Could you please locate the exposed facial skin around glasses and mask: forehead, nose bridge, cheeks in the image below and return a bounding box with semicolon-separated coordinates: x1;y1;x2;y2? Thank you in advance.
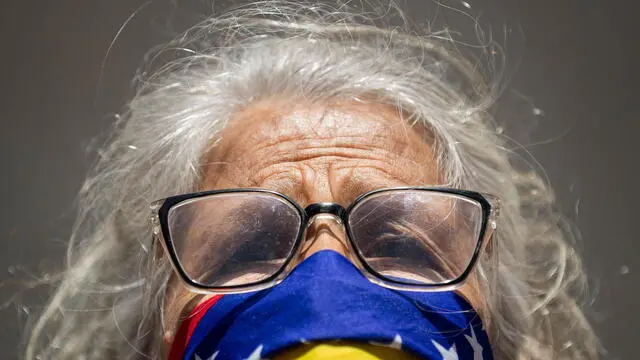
165;101;487;342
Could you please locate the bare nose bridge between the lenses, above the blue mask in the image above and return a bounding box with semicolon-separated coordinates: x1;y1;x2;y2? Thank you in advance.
301;214;349;259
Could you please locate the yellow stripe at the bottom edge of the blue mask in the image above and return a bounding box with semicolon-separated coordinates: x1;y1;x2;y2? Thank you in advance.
274;342;419;360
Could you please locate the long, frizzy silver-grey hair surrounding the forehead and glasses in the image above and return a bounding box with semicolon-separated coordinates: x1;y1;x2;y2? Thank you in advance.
25;1;599;360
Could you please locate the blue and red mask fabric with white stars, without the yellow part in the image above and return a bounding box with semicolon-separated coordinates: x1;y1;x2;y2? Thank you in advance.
169;250;493;360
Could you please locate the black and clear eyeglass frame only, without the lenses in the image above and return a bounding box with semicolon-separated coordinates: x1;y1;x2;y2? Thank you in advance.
151;186;500;294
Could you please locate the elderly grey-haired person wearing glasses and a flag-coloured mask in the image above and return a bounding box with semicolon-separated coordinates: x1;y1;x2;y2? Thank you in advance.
26;2;598;360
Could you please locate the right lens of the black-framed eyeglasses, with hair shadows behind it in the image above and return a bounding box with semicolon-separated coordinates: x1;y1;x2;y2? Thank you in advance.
349;190;482;285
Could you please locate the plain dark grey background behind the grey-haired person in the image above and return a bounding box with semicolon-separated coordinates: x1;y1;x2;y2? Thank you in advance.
0;0;640;359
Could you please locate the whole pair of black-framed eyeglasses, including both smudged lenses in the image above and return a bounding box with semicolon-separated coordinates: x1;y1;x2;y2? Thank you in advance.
151;187;499;294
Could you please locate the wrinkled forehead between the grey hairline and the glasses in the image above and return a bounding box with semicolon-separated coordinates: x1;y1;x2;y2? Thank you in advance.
203;101;439;197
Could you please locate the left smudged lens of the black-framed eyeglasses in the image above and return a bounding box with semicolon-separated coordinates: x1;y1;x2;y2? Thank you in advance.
168;192;302;287
